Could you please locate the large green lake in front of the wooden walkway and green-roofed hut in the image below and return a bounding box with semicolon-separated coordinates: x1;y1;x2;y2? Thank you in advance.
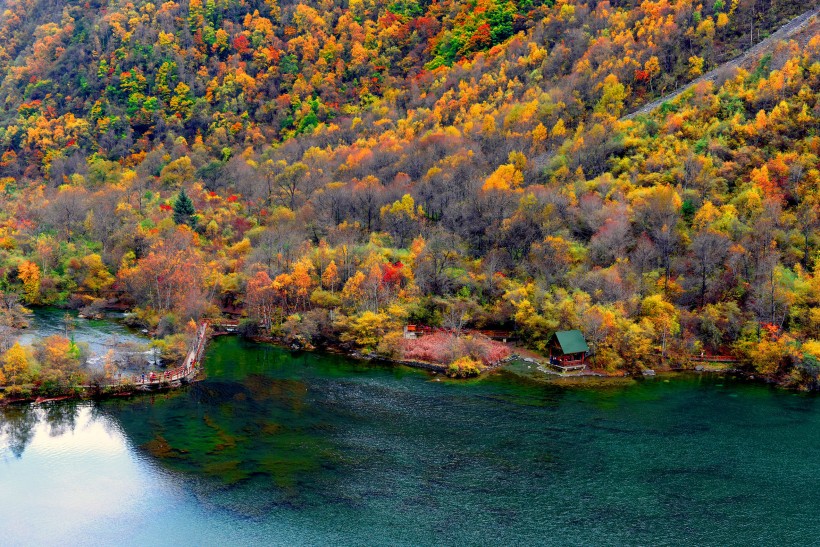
0;338;820;545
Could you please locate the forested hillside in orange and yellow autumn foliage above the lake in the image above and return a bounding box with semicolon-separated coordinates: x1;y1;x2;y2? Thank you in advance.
0;0;820;385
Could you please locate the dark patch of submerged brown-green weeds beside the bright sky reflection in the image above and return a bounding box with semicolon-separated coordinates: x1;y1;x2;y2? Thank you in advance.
100;374;324;508
